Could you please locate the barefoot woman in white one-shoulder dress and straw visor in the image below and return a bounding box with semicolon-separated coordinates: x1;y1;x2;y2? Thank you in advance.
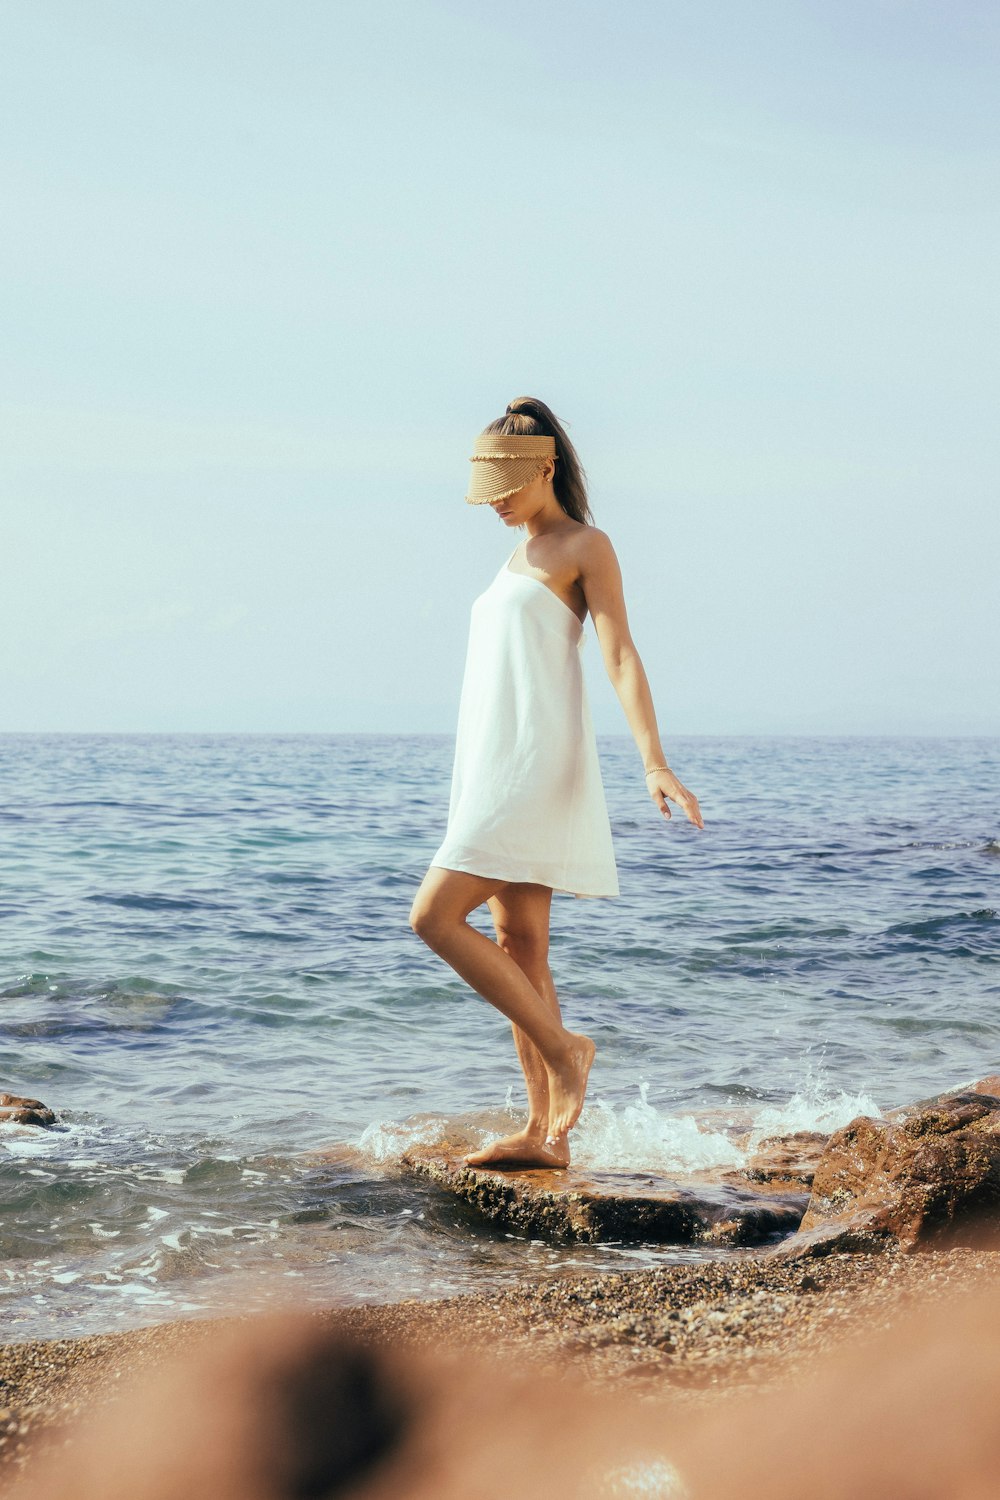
409;396;703;1167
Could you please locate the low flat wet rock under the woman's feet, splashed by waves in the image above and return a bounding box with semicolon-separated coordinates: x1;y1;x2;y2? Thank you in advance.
402;1140;808;1247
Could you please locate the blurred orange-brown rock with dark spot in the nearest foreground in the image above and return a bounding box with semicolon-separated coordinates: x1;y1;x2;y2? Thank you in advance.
15;1260;1000;1500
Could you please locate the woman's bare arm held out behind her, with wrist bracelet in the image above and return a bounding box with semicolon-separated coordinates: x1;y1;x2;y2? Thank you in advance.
580;527;705;828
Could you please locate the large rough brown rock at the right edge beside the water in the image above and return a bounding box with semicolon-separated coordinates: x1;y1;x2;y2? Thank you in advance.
780;1077;1000;1257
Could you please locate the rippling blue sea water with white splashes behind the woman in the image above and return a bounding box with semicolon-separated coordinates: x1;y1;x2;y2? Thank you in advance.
0;735;1000;1338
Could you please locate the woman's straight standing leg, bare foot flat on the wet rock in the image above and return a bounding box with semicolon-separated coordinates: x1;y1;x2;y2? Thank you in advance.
465;882;570;1167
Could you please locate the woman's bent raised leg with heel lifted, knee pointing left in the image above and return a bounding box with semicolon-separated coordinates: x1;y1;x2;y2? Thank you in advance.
409;866;594;1142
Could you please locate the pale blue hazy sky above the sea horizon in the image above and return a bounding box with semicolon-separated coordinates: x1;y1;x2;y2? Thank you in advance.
0;0;1000;738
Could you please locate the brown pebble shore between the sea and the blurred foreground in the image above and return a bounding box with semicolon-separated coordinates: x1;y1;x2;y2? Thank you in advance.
0;1250;1000;1467
